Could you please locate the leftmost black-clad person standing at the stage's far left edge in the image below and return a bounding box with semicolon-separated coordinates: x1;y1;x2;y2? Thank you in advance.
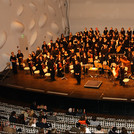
10;52;17;74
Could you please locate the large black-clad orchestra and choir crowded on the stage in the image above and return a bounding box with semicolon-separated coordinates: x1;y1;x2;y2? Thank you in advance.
10;27;134;85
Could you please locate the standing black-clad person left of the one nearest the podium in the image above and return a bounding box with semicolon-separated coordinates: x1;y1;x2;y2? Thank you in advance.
47;55;56;81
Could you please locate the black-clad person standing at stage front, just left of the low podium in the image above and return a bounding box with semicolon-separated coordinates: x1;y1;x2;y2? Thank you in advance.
74;60;81;85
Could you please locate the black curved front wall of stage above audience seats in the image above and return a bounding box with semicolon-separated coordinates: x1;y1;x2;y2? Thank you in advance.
0;87;134;116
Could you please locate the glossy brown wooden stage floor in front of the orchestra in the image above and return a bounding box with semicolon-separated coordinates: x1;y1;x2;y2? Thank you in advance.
1;70;134;101
